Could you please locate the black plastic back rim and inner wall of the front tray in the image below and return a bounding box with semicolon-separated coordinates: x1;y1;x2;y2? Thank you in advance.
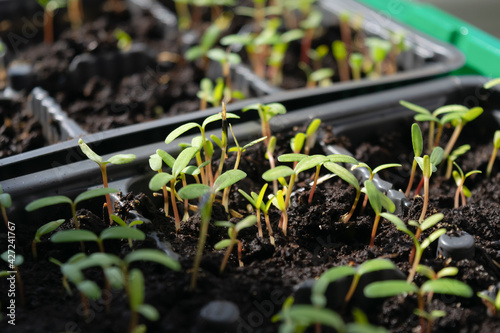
0;76;500;218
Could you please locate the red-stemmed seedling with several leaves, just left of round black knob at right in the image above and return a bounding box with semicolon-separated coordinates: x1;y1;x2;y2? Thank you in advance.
382;213;446;282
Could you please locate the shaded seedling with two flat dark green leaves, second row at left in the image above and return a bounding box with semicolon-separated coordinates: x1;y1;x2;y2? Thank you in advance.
50;226;146;253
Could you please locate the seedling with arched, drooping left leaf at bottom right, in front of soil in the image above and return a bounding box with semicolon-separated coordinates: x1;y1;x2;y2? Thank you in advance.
311;258;396;308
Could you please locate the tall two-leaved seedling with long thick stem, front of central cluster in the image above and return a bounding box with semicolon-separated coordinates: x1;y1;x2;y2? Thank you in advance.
179;170;247;289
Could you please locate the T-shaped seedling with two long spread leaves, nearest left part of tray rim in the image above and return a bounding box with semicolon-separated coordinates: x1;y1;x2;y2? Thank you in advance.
25;188;118;229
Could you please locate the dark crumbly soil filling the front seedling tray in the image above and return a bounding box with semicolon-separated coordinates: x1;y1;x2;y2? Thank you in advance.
0;117;500;332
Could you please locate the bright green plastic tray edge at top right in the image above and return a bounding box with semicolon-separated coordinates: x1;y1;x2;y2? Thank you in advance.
359;0;500;77
